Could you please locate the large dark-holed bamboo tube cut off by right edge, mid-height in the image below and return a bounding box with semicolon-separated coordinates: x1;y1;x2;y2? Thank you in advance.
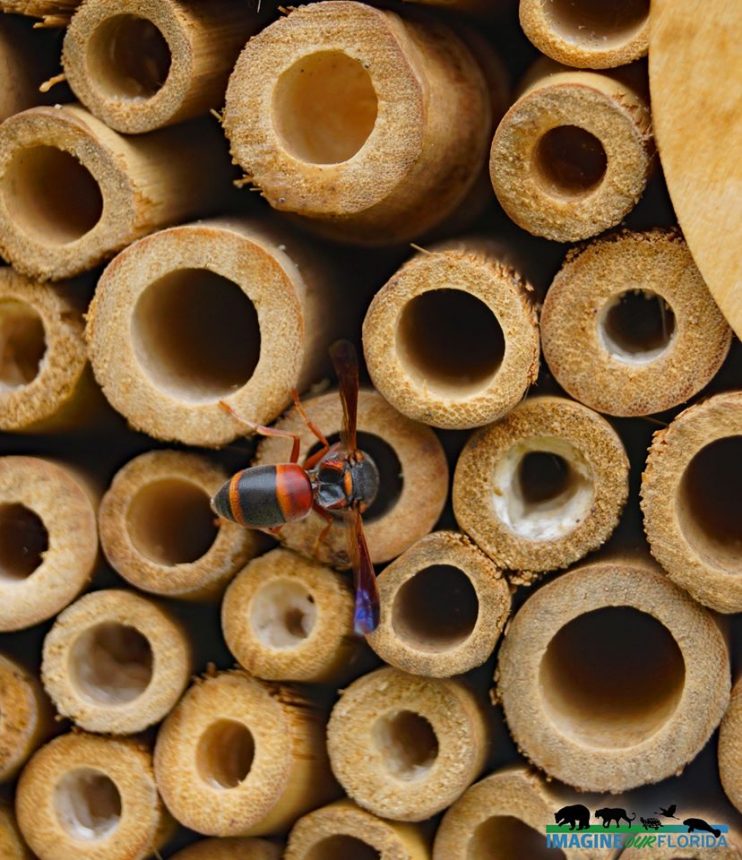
641;391;742;612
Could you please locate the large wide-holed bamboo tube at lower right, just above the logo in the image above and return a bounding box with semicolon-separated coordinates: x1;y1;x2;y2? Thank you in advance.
496;556;730;793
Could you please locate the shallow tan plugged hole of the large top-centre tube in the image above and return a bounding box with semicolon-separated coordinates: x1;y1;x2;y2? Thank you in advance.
273;51;378;164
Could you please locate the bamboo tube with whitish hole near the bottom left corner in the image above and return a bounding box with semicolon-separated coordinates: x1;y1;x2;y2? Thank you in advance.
16;732;172;860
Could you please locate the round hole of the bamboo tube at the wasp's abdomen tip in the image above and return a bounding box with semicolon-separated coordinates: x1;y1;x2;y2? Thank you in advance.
126;478;219;566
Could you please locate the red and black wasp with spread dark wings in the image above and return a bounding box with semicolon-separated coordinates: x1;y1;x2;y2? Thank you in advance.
211;341;379;635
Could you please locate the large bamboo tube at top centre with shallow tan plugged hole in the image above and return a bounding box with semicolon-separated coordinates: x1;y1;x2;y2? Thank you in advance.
224;0;492;244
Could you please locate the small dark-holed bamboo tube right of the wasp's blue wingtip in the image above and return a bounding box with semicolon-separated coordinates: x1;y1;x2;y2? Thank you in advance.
368;531;510;678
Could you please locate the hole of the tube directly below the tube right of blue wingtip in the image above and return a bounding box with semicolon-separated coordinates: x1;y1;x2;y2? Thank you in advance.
372;711;438;780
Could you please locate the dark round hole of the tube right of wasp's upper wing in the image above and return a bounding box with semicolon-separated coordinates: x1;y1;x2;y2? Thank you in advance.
397;289;505;400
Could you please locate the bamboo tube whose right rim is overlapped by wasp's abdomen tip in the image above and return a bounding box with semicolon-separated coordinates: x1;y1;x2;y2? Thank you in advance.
99;451;260;600
